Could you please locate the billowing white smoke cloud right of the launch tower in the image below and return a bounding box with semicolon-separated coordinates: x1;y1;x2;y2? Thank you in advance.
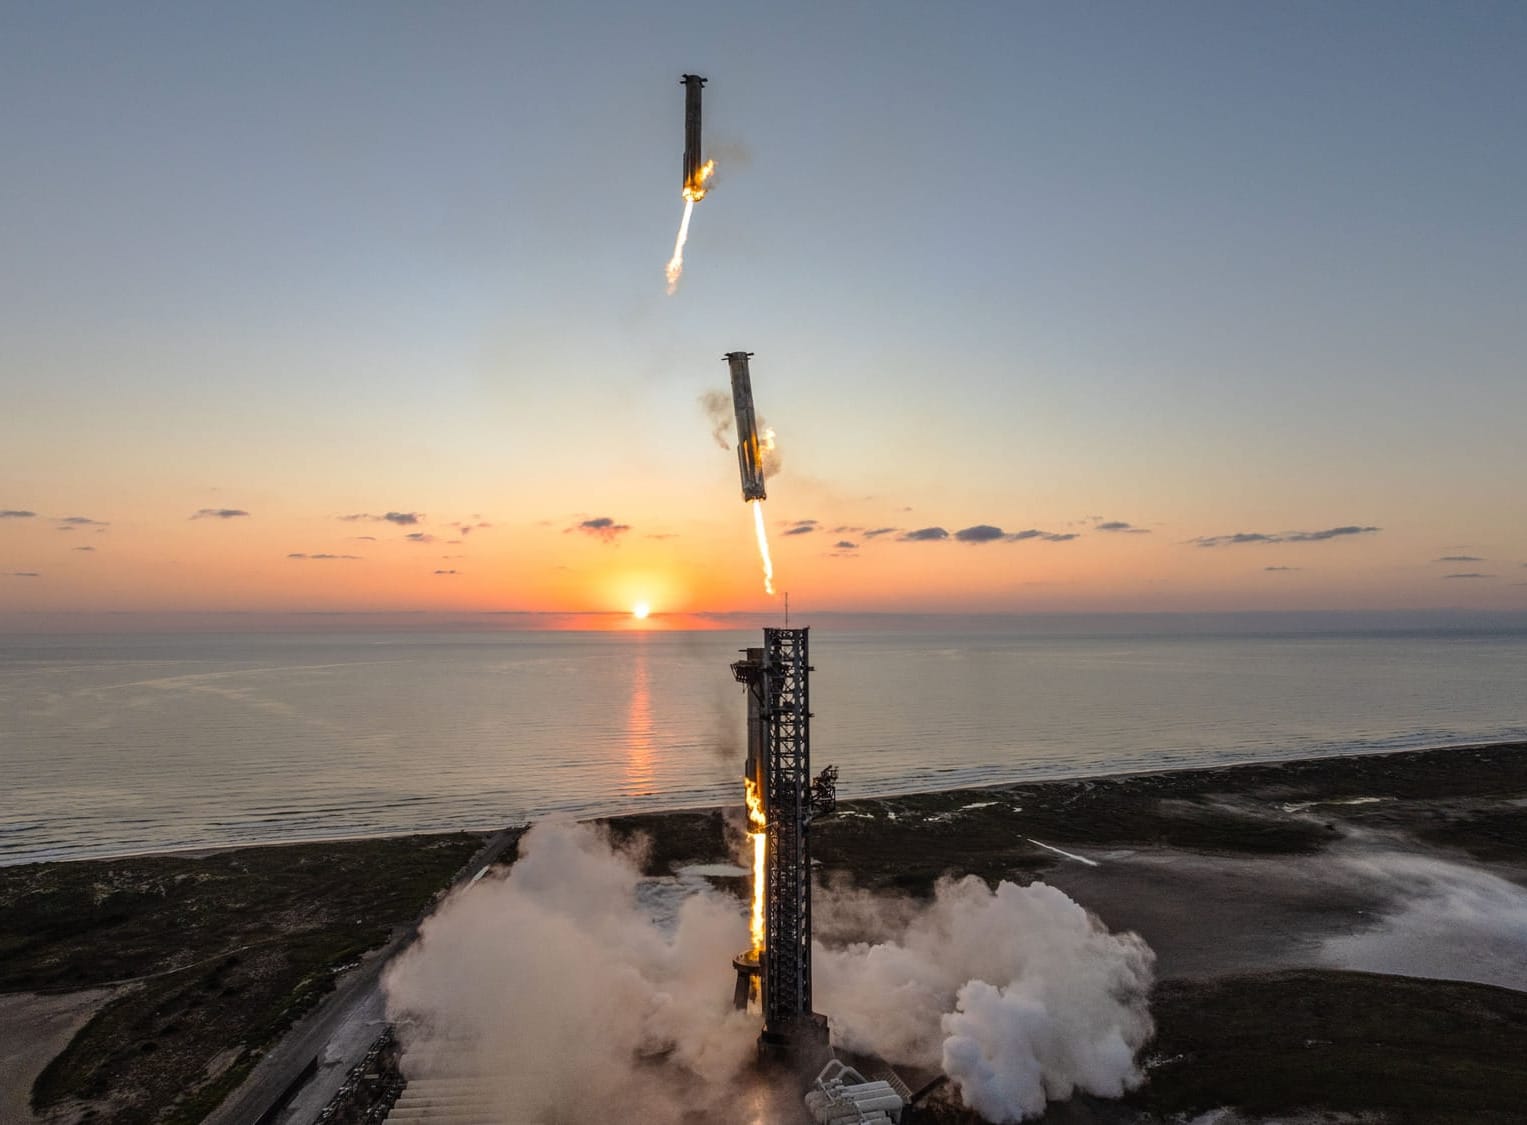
814;876;1156;1122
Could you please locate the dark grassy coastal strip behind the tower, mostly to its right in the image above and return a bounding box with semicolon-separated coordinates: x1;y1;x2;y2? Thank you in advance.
608;743;1527;895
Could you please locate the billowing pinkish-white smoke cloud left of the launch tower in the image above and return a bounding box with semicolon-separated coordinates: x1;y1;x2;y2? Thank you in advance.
385;821;759;1122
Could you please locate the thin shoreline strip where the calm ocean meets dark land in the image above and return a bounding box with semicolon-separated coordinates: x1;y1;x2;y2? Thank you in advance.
11;739;1527;870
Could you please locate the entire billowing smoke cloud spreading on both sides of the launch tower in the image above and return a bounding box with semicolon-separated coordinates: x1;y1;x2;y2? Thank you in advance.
385;820;1154;1122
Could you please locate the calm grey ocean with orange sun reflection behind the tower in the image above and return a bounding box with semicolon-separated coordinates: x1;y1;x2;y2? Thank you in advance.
0;627;1527;864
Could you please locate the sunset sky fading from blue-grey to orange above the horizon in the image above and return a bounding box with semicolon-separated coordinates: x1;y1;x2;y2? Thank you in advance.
0;0;1527;623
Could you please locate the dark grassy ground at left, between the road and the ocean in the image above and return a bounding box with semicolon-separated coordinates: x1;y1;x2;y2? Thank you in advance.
0;833;483;1125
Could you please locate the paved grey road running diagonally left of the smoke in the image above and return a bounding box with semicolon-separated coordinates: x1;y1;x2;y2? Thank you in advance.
203;829;519;1125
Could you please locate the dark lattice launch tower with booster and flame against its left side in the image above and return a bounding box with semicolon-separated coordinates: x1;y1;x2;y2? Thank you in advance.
731;629;837;1062
